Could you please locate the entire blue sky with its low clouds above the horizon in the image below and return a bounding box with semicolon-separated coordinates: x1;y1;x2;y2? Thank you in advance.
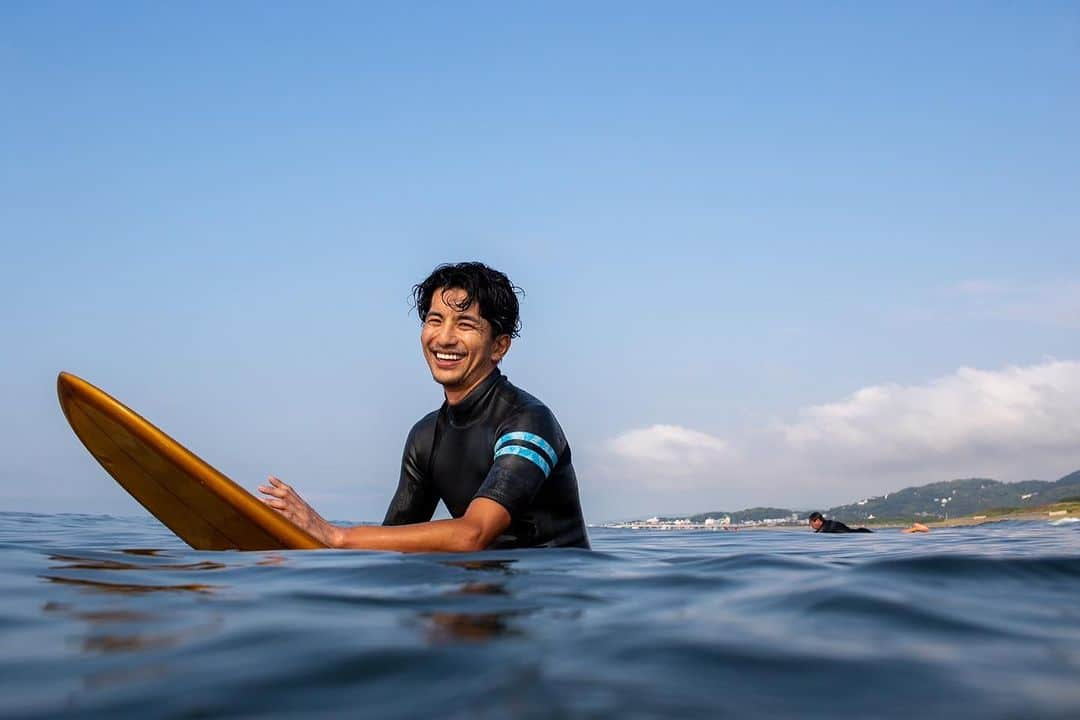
0;2;1080;521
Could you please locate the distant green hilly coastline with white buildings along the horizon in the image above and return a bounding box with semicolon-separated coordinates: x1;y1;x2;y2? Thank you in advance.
660;471;1080;525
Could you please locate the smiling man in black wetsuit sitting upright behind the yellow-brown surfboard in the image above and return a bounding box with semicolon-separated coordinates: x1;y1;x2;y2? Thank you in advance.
259;262;589;552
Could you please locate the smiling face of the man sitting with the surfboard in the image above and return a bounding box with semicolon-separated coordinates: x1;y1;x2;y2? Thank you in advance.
420;287;510;404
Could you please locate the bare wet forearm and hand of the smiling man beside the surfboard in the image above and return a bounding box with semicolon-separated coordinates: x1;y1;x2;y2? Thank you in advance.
259;477;510;553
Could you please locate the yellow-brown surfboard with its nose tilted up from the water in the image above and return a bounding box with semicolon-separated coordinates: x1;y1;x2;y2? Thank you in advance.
56;372;325;551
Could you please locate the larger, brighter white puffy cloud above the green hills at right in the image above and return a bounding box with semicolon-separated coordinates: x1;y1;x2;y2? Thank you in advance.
781;362;1080;472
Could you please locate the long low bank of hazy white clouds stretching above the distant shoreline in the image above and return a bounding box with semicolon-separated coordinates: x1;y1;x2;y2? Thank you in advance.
589;361;1080;516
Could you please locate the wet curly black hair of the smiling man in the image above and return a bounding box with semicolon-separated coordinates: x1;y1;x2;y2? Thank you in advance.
413;262;524;338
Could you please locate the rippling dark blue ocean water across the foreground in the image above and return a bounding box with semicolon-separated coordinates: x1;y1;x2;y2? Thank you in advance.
0;513;1080;719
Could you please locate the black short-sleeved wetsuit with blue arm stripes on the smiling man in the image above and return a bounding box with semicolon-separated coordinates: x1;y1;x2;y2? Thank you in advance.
382;368;589;548
